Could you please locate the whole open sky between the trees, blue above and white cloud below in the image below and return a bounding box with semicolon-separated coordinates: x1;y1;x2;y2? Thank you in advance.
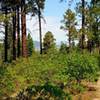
27;0;79;43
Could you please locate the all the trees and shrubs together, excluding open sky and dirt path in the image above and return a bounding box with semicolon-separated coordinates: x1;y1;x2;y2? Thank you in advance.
0;0;100;100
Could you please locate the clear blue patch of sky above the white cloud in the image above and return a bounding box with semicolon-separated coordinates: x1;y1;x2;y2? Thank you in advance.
44;0;76;17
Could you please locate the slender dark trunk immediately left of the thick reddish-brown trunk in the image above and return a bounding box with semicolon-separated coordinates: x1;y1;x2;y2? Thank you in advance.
17;6;21;57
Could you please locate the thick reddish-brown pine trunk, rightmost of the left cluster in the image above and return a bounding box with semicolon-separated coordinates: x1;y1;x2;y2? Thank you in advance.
21;0;27;57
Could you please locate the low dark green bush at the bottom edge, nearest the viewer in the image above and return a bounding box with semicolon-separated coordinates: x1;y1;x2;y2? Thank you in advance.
17;83;71;100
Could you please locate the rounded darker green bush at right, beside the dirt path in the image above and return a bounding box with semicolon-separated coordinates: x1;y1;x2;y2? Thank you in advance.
65;54;100;82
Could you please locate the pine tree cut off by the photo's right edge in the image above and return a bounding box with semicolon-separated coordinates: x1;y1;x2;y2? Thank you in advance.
90;0;100;53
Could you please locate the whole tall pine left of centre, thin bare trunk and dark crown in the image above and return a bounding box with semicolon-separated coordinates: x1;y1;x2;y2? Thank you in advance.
28;0;45;54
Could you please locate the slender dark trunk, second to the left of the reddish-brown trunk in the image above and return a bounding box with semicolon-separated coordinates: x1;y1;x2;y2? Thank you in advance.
13;8;16;60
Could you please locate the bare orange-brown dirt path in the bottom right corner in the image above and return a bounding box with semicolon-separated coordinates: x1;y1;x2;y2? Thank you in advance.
73;78;100;100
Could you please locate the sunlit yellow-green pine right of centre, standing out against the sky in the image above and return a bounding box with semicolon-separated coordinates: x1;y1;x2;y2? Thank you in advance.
61;9;77;48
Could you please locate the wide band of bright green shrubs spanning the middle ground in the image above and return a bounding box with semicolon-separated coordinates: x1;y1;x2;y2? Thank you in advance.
0;52;100;95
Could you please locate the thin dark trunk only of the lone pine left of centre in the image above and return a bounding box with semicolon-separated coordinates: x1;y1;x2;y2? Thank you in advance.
38;7;42;54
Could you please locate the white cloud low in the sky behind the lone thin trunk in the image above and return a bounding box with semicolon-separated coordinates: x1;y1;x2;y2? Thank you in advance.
27;16;67;42
